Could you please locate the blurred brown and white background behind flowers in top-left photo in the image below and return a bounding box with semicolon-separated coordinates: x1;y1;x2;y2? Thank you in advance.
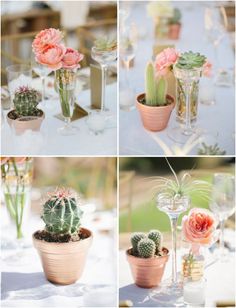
1;1;117;85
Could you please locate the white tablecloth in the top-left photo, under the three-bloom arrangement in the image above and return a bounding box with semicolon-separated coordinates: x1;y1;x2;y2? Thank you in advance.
1;84;117;156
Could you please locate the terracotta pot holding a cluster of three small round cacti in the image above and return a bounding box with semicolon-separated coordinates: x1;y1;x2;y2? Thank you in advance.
126;248;169;288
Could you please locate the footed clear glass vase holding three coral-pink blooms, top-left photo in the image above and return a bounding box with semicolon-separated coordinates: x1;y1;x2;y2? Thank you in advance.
55;69;79;135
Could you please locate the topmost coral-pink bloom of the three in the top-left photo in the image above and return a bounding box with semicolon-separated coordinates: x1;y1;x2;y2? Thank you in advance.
32;28;63;54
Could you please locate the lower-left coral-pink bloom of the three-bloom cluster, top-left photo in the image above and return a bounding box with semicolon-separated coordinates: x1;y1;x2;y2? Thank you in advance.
36;45;66;70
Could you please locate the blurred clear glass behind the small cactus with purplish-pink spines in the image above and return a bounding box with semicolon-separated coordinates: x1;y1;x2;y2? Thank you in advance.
6;64;32;104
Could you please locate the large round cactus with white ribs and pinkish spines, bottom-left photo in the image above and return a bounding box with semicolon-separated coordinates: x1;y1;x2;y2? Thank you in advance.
41;188;83;235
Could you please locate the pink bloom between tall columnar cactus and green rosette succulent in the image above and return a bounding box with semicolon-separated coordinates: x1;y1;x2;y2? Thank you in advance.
155;48;179;76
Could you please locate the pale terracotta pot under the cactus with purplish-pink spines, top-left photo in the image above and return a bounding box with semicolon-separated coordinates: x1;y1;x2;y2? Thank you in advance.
7;110;45;135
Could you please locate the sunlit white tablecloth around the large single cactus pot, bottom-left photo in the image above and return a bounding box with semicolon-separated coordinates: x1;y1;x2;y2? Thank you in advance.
1;208;117;308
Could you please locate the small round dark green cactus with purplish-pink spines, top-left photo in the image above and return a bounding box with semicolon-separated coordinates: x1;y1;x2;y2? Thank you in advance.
13;86;39;117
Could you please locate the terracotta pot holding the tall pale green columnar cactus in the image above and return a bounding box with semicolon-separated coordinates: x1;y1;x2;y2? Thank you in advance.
137;93;175;132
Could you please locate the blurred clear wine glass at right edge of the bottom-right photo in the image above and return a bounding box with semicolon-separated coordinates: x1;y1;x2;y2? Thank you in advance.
210;173;235;261
